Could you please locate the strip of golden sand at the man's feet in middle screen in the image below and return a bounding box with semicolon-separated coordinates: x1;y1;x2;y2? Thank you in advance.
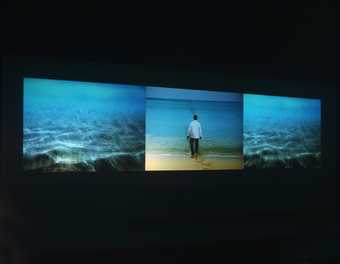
145;154;243;170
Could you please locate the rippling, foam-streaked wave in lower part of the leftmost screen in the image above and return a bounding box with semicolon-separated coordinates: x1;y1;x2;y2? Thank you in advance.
23;106;145;171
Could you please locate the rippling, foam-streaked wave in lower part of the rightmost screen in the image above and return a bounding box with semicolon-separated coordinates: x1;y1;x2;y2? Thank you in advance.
244;122;321;168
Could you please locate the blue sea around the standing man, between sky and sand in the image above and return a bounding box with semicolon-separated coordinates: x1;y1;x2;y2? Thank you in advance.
146;98;243;158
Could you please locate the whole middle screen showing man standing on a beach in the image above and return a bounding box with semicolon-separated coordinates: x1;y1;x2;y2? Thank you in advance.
145;87;243;171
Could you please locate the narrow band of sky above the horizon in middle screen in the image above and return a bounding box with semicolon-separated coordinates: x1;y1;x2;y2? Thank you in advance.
145;86;243;102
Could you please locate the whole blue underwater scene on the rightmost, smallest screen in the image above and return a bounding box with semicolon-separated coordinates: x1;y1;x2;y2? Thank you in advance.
244;94;321;168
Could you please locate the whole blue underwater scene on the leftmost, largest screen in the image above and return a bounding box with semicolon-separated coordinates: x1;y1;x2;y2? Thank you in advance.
23;78;145;171
